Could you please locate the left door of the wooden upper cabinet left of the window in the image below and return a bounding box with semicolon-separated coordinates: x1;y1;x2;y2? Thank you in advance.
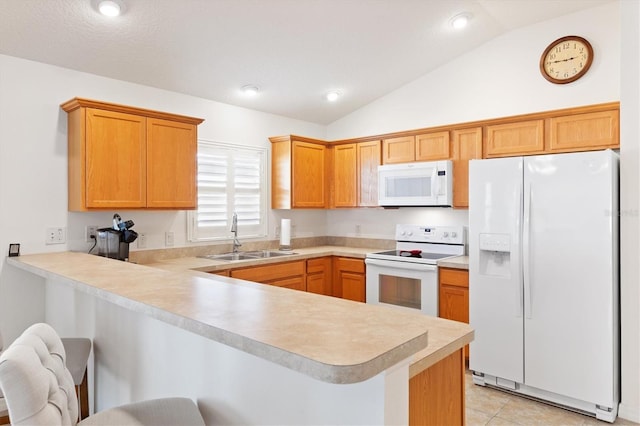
85;108;147;208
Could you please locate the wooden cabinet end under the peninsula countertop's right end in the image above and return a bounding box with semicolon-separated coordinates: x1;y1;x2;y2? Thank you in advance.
409;349;465;426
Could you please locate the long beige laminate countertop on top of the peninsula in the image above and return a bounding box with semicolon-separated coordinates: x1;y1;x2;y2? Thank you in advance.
7;250;473;383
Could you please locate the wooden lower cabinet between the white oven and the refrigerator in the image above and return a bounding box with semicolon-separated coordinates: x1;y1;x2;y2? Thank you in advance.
438;268;469;359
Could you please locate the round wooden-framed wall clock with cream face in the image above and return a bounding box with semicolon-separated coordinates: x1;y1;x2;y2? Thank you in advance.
540;36;593;84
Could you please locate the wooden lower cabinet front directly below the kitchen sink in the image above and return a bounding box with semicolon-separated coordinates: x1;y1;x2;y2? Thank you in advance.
231;260;307;291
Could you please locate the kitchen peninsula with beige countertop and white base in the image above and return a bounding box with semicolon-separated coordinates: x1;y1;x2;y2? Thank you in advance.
7;252;473;424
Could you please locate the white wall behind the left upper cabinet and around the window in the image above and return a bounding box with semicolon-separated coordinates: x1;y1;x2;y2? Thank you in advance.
0;55;326;342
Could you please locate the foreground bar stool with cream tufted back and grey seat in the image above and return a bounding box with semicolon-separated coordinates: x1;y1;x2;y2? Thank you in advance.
0;323;204;426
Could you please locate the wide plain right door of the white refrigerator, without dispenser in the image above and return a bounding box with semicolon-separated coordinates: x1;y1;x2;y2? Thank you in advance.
524;151;618;407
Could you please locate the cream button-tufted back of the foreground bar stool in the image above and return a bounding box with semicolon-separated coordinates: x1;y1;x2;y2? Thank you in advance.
0;323;78;426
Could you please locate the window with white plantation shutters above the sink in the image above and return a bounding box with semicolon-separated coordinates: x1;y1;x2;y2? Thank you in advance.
188;140;267;241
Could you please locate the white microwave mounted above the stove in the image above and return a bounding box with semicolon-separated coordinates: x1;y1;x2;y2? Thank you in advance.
378;160;453;207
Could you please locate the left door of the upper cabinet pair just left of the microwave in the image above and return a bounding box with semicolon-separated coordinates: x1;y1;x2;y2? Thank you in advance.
333;143;358;207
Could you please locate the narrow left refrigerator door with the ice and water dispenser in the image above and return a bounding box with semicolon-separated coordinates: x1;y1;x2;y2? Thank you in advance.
469;157;524;383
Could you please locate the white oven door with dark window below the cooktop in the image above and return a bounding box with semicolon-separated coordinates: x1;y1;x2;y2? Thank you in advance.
365;258;438;317
